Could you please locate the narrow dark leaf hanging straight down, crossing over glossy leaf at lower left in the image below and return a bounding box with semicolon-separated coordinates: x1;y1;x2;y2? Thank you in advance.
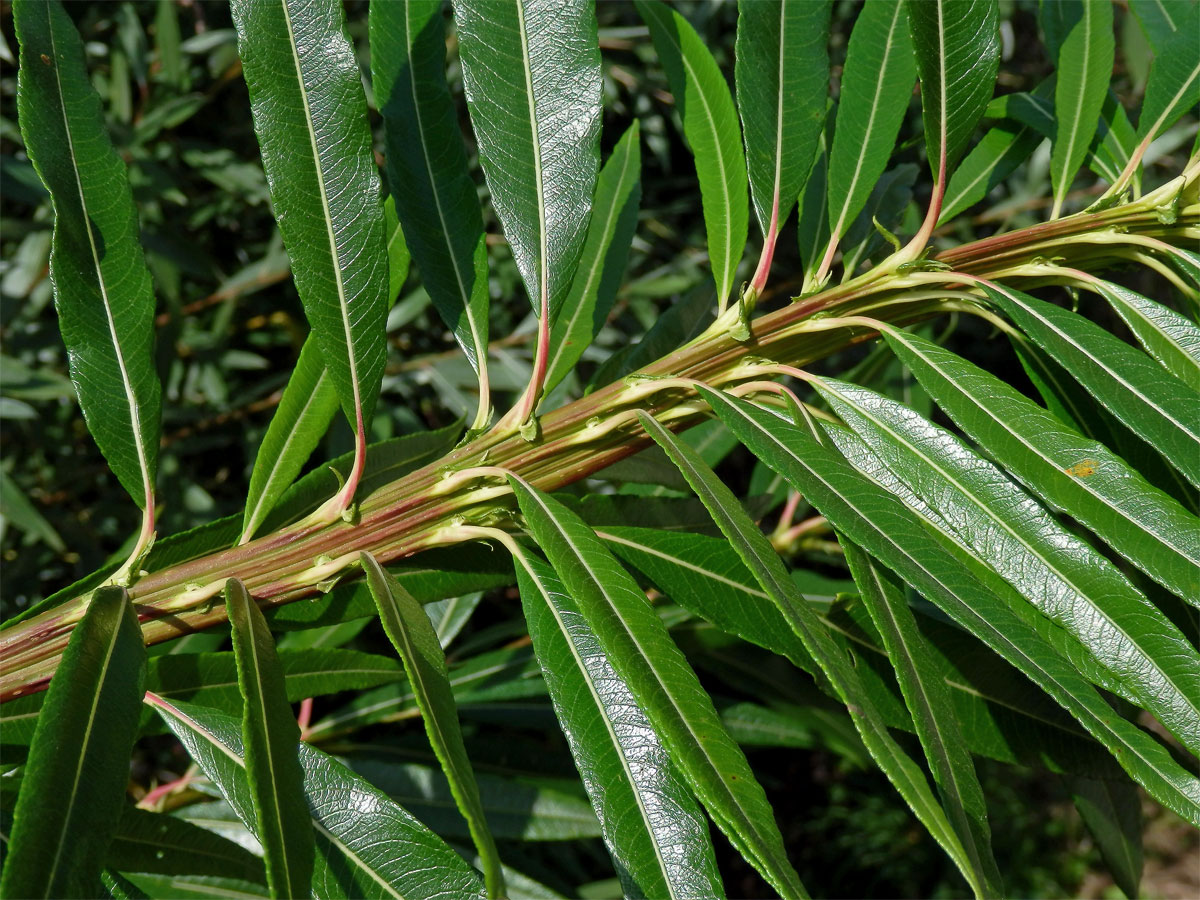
224;578;313;896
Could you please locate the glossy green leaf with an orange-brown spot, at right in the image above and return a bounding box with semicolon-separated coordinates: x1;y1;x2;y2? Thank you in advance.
884;331;1200;607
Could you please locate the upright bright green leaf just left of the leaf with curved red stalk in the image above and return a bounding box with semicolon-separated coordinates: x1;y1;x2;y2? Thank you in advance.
828;1;917;247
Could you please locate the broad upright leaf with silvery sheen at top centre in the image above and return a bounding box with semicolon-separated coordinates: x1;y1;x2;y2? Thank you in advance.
455;0;600;319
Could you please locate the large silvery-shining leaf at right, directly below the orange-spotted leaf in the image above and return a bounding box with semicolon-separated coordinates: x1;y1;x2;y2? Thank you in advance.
817;379;1200;752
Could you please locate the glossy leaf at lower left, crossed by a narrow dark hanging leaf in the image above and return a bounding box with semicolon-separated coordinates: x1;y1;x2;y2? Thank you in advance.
148;695;482;900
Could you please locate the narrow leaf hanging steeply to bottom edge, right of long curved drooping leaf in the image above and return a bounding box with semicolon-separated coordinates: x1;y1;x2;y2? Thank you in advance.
842;541;1003;896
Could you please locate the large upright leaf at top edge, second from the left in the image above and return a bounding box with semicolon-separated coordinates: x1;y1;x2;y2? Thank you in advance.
233;0;388;432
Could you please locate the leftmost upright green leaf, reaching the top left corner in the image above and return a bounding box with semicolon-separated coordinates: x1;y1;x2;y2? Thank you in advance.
13;0;161;520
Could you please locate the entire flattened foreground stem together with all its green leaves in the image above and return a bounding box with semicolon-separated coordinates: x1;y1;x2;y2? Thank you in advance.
0;0;1200;898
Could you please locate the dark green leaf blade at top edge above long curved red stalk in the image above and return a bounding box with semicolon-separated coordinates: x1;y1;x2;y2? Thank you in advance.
905;0;1000;184
